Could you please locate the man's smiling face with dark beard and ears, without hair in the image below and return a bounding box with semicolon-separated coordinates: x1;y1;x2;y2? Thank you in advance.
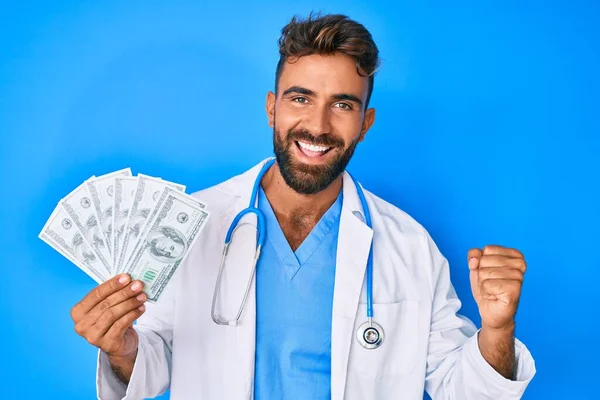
267;54;375;194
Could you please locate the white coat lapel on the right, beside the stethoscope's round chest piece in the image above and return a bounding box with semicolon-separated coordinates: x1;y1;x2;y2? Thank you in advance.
331;173;373;400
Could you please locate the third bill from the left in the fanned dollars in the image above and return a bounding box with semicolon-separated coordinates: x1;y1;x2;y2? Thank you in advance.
87;168;131;256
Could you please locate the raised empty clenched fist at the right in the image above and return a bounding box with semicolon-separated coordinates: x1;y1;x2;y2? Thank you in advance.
468;246;527;329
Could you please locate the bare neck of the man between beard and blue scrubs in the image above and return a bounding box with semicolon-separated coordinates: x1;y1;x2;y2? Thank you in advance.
261;163;342;219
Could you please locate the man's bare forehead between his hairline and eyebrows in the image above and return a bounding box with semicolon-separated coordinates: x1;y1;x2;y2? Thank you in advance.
278;53;369;101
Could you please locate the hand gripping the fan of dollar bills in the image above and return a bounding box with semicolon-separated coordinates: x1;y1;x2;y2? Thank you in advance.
71;274;146;359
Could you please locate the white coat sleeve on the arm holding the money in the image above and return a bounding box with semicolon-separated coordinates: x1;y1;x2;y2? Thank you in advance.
96;282;175;400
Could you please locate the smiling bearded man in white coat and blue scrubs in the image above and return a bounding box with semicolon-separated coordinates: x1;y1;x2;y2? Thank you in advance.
71;15;535;400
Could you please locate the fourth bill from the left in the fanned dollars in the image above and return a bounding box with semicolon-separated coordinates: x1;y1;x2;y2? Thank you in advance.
111;176;138;274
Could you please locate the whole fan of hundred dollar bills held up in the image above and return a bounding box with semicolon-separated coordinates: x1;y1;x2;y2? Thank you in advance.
39;168;209;302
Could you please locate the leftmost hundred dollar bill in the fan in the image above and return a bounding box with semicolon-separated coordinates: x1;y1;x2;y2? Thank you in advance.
39;204;109;283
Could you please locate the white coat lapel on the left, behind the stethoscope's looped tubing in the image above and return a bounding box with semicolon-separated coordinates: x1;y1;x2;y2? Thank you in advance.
216;160;274;399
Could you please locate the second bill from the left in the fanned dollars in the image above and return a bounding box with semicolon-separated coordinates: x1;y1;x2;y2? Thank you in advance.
60;178;111;271
